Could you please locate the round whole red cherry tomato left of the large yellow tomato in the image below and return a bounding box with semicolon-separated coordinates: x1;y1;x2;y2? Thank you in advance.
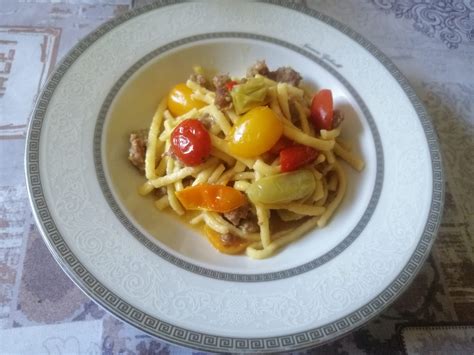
171;118;211;166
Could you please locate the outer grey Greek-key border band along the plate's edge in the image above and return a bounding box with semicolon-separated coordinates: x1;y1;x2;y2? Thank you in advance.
24;0;445;352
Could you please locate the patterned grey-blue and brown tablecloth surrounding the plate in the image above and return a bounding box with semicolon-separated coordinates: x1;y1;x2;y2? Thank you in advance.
0;0;474;354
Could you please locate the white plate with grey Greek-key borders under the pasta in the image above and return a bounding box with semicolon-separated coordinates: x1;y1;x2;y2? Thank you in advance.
26;1;443;351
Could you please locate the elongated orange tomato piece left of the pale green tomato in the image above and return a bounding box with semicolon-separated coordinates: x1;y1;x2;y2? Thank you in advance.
176;184;247;213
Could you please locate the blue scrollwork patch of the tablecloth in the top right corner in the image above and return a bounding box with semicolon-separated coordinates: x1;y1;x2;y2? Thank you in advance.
370;0;474;49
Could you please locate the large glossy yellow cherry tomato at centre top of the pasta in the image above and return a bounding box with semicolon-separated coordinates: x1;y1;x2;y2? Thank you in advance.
229;106;283;158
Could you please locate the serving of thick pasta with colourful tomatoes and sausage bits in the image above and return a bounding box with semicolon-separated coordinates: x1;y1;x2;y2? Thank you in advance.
129;61;364;259
